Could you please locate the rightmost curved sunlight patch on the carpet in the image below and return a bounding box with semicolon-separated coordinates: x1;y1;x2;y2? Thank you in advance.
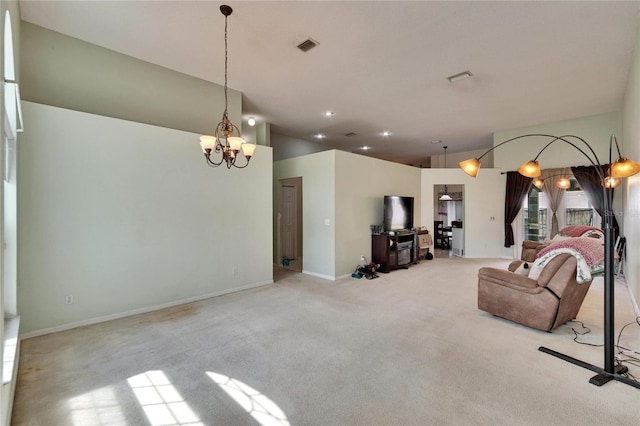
207;371;289;426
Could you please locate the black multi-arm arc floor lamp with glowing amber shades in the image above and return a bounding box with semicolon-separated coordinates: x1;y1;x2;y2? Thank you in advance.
459;133;640;389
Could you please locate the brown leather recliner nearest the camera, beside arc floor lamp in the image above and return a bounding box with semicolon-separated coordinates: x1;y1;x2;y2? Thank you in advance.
478;253;591;331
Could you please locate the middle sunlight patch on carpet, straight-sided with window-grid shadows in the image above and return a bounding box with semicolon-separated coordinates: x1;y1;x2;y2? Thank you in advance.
127;370;204;426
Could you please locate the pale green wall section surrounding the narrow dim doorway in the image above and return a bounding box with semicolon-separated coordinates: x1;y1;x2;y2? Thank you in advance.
273;151;336;279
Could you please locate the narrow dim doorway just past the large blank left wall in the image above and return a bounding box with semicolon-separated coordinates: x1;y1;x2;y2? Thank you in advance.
276;177;303;272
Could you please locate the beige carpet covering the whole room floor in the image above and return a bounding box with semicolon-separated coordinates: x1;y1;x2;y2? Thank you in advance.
13;258;640;426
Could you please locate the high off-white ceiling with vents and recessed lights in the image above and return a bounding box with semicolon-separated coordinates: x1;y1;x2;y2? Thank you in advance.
20;0;640;165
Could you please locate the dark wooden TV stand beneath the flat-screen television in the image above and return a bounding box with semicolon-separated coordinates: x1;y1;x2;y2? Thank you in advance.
371;231;418;272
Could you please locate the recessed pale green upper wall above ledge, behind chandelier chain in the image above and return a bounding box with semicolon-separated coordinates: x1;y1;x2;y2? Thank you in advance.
20;22;242;136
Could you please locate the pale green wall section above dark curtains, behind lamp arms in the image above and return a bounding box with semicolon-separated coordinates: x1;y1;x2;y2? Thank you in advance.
493;111;622;171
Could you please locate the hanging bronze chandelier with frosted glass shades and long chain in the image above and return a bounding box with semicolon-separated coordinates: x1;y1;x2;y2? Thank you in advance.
200;4;256;169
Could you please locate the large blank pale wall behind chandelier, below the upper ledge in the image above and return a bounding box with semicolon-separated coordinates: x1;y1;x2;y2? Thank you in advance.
18;102;273;335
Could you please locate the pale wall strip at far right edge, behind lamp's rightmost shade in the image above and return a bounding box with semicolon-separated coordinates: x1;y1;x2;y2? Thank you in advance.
617;18;640;315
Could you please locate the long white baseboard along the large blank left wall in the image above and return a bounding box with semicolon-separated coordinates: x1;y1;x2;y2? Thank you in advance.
20;280;273;340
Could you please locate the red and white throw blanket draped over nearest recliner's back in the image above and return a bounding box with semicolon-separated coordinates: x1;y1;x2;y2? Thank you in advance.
534;237;604;284
